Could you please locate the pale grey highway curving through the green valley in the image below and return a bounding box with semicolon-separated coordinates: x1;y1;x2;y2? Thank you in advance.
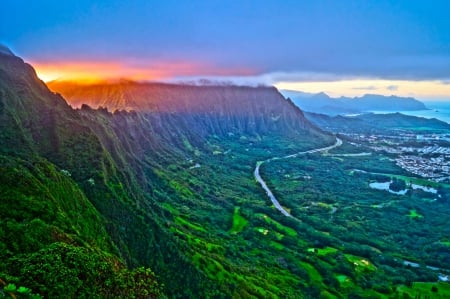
253;137;342;217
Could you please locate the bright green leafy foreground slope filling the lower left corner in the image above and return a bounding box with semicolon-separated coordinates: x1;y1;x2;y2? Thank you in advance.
0;156;161;298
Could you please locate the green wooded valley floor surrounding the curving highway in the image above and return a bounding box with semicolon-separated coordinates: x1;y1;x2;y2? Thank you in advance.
156;133;450;298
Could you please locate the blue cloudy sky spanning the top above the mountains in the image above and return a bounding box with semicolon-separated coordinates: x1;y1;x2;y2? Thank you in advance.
0;0;450;99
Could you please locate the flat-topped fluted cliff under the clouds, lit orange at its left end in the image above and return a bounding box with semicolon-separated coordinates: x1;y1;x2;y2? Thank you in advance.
49;82;317;135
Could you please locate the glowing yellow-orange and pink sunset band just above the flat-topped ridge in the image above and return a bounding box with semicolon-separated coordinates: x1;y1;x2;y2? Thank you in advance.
31;61;255;82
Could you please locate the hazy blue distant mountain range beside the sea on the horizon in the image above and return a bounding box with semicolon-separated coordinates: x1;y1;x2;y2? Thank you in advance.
281;90;427;115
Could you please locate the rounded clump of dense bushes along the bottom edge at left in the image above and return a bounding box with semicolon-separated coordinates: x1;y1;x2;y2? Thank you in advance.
3;243;161;298
